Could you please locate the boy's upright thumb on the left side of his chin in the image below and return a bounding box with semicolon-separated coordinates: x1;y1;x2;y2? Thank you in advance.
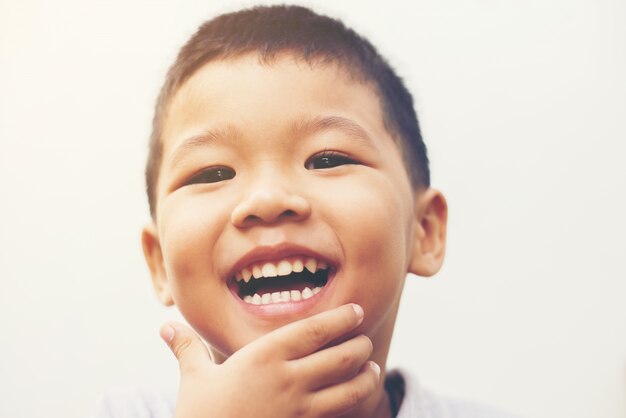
160;322;212;374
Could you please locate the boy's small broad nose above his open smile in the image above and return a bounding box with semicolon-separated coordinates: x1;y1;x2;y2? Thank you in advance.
231;184;311;228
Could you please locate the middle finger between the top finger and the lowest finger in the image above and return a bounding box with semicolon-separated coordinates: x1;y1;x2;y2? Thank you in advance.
291;335;372;390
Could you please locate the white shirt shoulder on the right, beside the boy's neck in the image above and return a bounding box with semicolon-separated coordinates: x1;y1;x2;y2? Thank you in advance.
391;370;518;418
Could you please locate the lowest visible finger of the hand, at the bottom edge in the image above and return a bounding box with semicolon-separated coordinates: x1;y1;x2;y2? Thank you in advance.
310;361;380;416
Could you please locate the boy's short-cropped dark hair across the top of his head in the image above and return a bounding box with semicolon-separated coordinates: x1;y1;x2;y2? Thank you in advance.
146;6;430;217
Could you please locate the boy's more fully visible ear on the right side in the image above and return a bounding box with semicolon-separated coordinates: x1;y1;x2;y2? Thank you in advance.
409;188;448;277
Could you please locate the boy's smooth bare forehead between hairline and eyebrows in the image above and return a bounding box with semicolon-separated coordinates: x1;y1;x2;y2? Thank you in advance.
161;54;386;155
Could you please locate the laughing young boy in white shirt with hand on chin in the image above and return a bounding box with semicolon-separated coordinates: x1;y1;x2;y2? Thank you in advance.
97;6;516;418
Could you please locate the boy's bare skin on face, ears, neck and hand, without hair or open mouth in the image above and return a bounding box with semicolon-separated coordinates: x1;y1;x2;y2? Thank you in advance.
142;54;447;417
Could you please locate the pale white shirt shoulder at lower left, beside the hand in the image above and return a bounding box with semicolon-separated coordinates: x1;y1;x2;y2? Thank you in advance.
92;387;176;418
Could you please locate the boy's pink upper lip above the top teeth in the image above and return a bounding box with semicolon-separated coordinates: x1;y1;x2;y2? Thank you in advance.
226;243;337;282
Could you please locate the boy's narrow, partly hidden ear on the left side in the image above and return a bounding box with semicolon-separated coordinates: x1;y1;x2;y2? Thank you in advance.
141;222;174;306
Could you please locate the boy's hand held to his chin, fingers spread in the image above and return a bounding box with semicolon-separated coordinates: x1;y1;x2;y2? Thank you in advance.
161;304;380;418
